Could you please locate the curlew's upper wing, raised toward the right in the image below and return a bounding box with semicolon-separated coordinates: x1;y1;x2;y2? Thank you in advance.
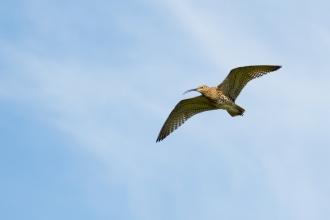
218;66;281;101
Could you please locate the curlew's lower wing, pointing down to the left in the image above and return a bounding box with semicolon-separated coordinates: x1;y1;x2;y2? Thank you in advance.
156;96;218;142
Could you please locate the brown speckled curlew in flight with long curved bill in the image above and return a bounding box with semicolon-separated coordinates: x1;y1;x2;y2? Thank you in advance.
156;65;281;143
